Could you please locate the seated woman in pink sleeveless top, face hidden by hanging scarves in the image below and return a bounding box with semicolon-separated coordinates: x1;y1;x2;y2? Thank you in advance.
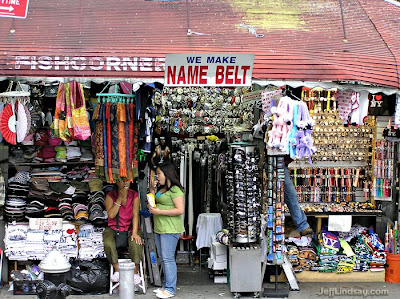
103;182;143;284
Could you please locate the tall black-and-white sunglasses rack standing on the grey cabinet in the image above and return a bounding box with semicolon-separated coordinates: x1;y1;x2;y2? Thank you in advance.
226;145;261;244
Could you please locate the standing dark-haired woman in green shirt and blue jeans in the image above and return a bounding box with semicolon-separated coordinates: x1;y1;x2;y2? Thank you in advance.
149;162;185;298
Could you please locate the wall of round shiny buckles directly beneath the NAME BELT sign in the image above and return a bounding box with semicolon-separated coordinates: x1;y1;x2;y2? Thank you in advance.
155;87;254;136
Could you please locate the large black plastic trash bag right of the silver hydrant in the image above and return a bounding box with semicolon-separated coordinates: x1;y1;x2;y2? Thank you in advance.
66;260;110;294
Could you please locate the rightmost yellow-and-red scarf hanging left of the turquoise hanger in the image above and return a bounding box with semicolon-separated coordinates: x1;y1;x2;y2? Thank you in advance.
71;82;91;140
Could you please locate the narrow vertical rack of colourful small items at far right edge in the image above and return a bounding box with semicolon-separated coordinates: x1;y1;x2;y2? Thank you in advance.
373;140;394;201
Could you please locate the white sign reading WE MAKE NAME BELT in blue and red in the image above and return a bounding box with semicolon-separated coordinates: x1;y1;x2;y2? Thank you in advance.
164;53;254;86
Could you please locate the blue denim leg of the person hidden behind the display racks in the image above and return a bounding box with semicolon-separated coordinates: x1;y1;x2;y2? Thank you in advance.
285;166;310;232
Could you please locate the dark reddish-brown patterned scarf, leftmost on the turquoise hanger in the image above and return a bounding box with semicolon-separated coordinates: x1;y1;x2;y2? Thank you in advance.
92;103;105;180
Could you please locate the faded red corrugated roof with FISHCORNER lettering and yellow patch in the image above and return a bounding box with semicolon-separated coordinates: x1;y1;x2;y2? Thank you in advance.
0;0;400;88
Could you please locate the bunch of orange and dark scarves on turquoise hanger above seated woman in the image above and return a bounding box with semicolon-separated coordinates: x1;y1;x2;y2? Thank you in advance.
92;84;139;183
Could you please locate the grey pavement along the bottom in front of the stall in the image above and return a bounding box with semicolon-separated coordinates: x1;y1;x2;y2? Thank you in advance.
0;266;400;299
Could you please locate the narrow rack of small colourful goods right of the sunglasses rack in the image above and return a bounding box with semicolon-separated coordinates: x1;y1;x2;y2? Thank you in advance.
264;156;285;264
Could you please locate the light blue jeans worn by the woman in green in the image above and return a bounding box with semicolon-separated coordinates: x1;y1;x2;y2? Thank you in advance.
155;233;180;295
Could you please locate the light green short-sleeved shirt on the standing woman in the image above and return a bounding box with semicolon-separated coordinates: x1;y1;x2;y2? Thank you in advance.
153;186;185;234
